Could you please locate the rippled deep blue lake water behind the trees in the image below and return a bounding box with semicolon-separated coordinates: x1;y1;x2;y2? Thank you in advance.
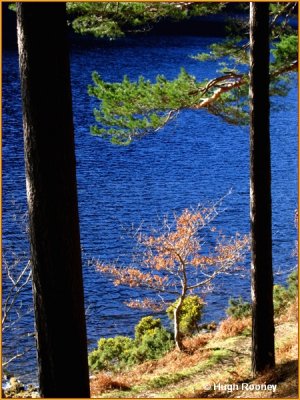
2;36;297;382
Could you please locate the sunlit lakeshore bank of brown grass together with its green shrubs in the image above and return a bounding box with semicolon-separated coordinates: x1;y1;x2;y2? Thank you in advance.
2;275;298;398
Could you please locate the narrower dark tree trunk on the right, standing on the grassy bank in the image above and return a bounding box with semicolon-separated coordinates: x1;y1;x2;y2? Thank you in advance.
250;2;275;375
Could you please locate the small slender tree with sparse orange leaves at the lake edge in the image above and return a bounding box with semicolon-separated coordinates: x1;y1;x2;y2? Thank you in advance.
97;206;249;350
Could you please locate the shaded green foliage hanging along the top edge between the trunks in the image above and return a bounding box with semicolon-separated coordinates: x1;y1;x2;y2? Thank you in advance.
67;2;225;40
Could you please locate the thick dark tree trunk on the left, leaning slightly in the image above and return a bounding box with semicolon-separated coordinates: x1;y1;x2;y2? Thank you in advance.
17;3;89;398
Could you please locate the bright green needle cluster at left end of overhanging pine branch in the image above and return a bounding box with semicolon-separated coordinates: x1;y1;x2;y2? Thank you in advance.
88;68;201;145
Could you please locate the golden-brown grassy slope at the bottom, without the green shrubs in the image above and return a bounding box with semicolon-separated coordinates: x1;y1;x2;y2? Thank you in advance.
91;300;298;398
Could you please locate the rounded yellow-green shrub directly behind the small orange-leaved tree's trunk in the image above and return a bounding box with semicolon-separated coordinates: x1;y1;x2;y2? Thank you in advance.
167;295;204;335
